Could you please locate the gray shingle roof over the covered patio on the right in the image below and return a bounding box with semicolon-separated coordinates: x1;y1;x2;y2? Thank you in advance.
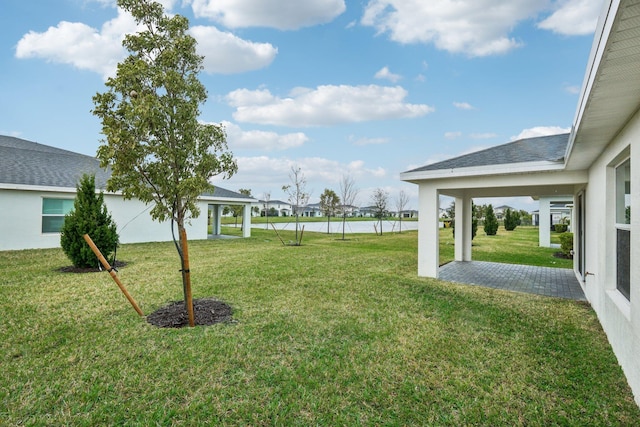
409;133;569;172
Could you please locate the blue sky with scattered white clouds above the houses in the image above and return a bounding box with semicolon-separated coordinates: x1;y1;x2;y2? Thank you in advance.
0;0;603;210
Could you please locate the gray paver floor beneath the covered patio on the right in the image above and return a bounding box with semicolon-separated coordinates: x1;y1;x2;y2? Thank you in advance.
438;261;587;301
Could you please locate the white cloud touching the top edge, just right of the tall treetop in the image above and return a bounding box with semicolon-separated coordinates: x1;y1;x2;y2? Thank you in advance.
191;0;346;30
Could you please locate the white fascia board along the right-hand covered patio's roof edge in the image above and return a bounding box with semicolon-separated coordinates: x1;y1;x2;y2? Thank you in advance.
400;161;564;182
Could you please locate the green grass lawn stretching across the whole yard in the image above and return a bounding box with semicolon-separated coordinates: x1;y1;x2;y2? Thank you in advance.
0;229;640;426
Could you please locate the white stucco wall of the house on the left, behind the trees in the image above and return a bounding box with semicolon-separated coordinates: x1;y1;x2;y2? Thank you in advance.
0;189;208;250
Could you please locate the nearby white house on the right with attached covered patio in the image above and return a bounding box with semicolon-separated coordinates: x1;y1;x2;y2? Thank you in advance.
401;0;640;404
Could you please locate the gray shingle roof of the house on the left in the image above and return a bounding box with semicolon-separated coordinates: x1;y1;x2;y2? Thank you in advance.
0;135;252;200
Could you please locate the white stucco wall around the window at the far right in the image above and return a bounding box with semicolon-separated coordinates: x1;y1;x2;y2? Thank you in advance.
576;108;640;404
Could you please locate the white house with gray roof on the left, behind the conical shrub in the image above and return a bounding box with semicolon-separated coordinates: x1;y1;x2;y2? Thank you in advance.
0;136;255;250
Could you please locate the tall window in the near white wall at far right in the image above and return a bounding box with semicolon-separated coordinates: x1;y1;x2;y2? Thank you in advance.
615;159;631;300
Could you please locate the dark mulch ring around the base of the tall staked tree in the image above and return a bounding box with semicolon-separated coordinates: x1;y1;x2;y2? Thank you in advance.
147;298;233;328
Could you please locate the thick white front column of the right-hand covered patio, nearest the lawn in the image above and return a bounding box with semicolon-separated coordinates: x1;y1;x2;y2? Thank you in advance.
418;183;440;278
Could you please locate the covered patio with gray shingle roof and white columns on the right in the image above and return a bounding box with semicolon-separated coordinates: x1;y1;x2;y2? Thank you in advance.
401;134;588;278
